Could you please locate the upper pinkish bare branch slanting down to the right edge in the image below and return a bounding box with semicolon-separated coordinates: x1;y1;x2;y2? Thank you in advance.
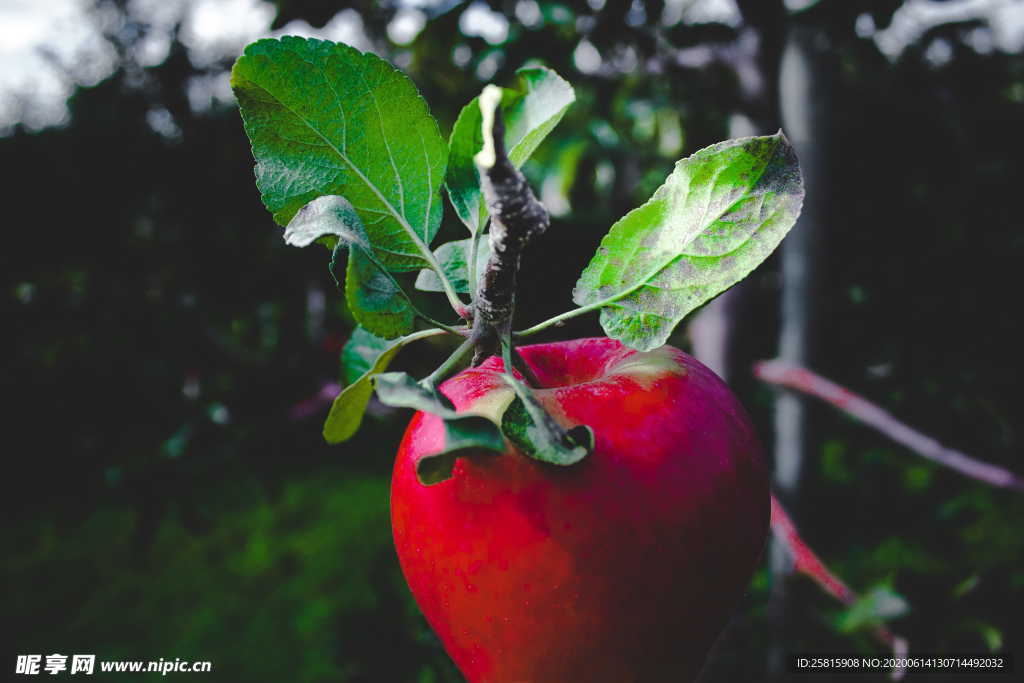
754;360;1024;492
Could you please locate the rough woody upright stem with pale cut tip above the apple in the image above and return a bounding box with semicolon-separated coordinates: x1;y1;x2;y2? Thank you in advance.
470;102;551;366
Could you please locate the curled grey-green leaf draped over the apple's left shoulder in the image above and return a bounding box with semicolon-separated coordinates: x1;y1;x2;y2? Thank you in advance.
374;373;505;485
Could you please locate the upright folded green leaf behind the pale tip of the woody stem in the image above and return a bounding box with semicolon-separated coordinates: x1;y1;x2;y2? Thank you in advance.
445;67;575;234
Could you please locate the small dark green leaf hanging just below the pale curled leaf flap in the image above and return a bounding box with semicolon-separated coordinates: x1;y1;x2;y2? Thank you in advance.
345;244;416;339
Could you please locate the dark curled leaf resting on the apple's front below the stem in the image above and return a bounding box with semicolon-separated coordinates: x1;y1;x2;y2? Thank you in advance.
502;375;594;465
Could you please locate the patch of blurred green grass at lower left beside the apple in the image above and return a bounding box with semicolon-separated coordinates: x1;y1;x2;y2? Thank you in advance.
7;475;456;681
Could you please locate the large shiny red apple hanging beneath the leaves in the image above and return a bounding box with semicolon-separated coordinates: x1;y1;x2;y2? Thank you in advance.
391;338;769;683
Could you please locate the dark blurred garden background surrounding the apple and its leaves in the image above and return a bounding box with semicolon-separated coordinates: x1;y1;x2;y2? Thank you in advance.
0;0;1024;683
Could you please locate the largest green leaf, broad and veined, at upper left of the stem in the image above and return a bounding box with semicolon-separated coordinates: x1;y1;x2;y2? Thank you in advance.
231;36;447;270
